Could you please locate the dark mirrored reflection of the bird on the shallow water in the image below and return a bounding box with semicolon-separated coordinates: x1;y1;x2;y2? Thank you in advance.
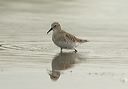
49;52;79;81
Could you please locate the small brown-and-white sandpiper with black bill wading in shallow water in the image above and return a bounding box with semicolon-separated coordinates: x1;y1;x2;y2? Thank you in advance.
47;22;88;52
